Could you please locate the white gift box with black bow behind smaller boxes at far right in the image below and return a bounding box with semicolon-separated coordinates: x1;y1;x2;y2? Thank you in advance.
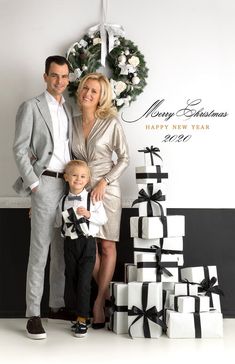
180;265;223;312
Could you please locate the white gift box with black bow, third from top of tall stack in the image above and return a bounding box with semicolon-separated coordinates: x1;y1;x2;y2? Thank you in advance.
132;183;166;216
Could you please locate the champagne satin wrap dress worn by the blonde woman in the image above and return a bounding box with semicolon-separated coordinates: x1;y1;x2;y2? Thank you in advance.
72;116;129;241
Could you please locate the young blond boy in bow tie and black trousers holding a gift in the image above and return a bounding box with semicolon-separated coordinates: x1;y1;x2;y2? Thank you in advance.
56;160;107;337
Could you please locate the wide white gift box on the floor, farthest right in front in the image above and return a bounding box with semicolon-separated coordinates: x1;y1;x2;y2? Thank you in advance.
166;310;223;339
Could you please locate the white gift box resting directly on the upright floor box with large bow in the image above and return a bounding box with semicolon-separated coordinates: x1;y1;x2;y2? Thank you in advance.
137;254;179;282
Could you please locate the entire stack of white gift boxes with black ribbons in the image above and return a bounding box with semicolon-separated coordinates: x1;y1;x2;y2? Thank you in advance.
109;146;223;338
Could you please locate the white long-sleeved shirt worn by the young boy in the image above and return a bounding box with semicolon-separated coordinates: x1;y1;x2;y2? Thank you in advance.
55;189;108;236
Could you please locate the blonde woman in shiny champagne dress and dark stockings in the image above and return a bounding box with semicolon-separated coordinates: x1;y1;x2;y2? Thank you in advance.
72;73;129;329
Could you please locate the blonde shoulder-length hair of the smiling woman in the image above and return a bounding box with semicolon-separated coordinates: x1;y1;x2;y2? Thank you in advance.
76;72;117;119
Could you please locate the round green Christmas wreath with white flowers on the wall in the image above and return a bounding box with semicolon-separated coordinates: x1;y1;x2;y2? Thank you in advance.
66;31;148;109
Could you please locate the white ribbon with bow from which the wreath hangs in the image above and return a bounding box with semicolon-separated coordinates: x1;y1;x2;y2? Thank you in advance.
88;0;125;67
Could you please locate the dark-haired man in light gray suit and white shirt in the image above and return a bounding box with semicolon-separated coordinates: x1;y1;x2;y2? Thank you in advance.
13;56;72;339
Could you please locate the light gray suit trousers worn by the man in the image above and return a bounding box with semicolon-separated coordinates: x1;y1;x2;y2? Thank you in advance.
26;175;65;317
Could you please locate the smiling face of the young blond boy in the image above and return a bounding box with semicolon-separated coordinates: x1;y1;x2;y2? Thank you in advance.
64;166;90;195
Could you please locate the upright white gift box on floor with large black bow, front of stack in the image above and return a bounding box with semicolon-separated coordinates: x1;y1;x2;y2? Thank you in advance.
128;282;163;338
